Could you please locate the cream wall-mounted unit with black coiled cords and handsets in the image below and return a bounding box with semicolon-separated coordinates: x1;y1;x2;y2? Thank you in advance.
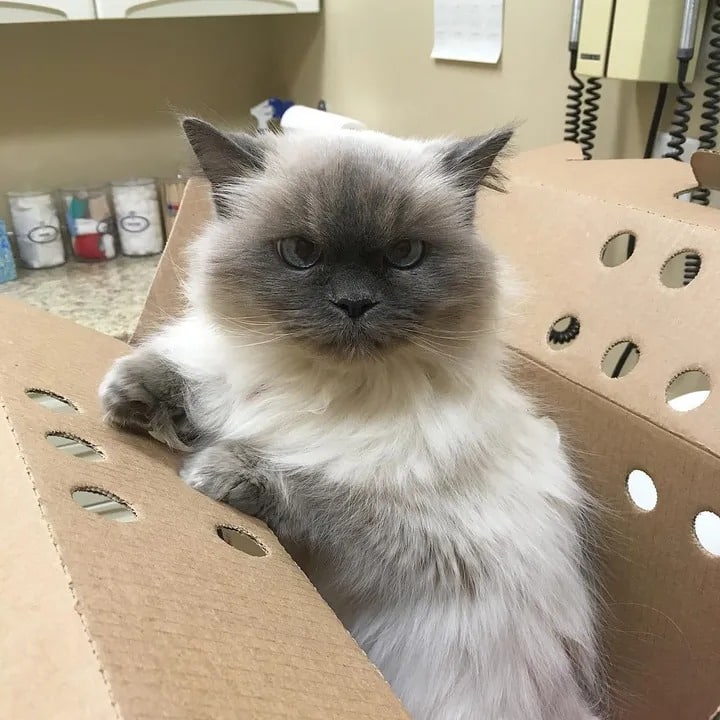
565;0;720;174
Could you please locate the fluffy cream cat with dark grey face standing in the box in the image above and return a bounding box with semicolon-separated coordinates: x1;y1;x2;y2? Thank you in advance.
100;119;597;720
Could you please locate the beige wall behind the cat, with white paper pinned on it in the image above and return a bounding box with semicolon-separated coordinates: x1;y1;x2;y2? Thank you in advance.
0;0;699;229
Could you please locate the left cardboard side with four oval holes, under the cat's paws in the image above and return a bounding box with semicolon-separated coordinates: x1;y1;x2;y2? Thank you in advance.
0;300;407;720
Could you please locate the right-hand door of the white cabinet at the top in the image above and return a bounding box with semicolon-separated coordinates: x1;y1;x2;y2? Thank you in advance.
95;0;320;18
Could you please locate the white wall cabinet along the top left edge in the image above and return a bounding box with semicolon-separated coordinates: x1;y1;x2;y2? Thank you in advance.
0;0;320;23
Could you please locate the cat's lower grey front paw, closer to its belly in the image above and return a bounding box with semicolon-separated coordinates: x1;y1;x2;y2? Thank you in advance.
180;442;274;522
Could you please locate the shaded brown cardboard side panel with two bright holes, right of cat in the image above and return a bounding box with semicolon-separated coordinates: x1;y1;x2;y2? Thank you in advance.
515;357;720;720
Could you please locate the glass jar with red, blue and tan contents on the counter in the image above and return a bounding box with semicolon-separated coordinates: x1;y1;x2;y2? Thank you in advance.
60;186;117;261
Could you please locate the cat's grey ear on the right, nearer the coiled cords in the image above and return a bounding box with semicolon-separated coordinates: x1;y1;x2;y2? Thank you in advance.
439;127;515;197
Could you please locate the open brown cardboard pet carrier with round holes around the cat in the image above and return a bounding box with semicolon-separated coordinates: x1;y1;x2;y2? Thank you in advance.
0;145;720;720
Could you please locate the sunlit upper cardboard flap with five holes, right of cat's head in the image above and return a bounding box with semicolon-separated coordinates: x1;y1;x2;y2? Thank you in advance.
479;152;720;453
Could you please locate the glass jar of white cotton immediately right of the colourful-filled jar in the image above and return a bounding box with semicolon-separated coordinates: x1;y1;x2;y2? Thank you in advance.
112;178;165;255
